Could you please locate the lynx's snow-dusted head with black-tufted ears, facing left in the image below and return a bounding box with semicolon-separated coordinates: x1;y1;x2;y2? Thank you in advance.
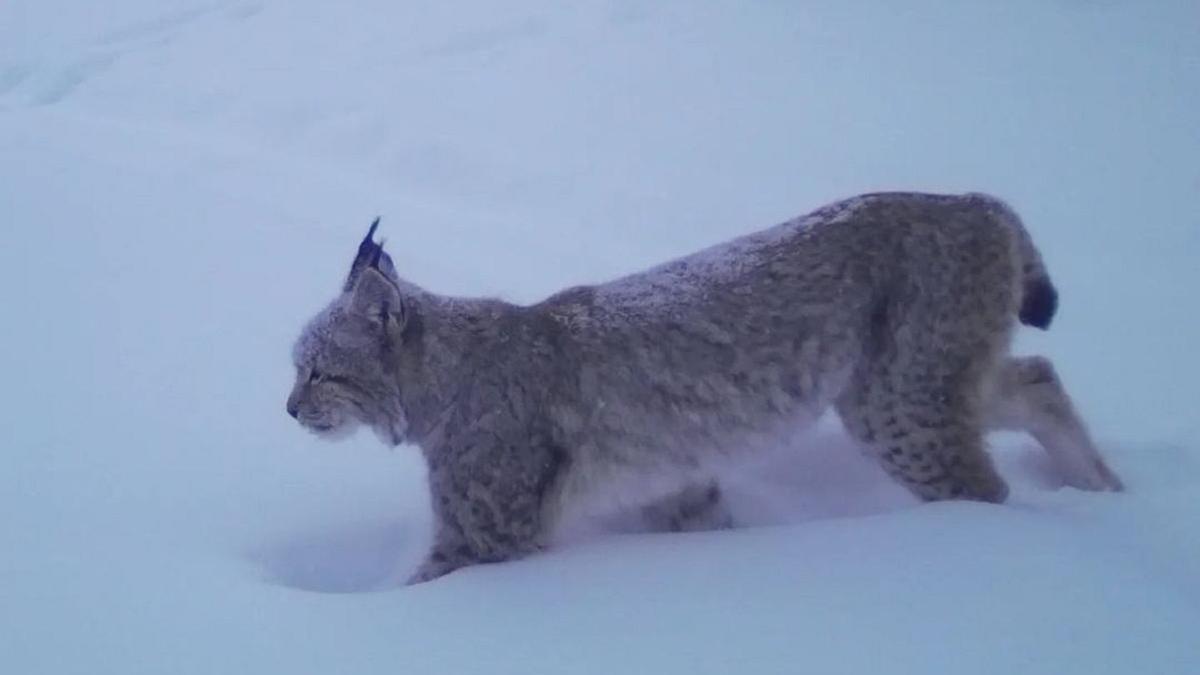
287;219;412;446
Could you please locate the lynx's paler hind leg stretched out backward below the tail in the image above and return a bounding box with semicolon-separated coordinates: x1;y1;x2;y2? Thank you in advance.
985;357;1124;490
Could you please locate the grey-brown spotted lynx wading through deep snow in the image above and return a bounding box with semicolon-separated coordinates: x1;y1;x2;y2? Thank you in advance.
287;192;1122;583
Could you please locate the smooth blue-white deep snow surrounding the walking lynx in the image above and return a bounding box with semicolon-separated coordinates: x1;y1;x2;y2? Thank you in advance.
0;0;1200;674
